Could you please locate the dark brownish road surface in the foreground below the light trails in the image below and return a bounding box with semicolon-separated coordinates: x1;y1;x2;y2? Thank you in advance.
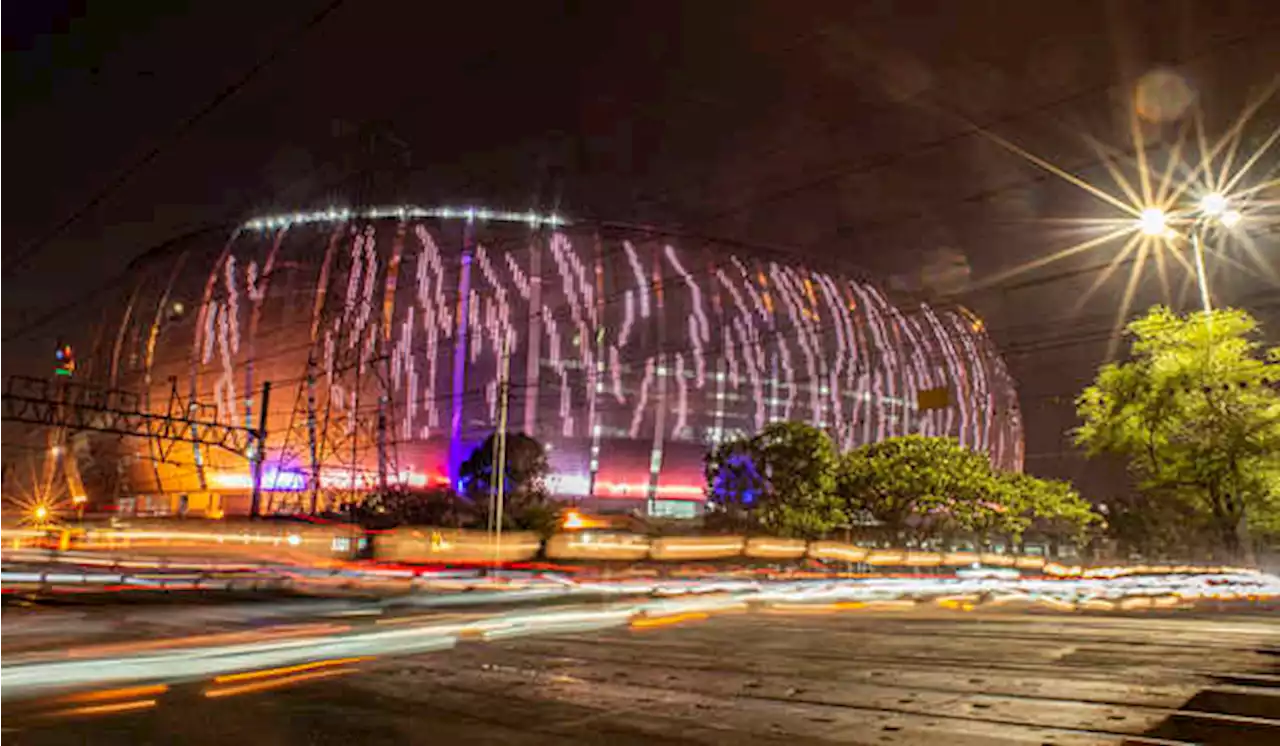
0;612;1280;746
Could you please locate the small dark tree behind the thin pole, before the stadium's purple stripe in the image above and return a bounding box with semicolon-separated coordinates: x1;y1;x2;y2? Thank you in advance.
458;433;557;534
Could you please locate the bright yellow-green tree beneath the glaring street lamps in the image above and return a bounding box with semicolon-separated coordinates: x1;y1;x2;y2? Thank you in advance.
1075;306;1280;559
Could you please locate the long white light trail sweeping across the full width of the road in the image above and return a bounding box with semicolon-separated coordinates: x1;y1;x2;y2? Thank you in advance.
0;571;1280;700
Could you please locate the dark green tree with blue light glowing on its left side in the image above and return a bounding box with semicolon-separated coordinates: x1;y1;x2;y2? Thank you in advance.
707;422;845;539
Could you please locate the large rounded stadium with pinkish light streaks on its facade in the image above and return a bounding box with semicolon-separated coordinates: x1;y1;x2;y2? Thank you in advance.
91;207;1023;517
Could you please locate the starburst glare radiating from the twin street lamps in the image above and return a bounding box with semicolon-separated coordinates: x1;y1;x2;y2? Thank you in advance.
974;73;1280;356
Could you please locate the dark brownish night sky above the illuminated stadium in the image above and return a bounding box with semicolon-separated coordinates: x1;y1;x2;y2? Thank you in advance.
0;0;1280;499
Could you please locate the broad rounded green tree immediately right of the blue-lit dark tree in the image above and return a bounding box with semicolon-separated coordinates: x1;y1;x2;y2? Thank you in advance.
838;435;1008;543
